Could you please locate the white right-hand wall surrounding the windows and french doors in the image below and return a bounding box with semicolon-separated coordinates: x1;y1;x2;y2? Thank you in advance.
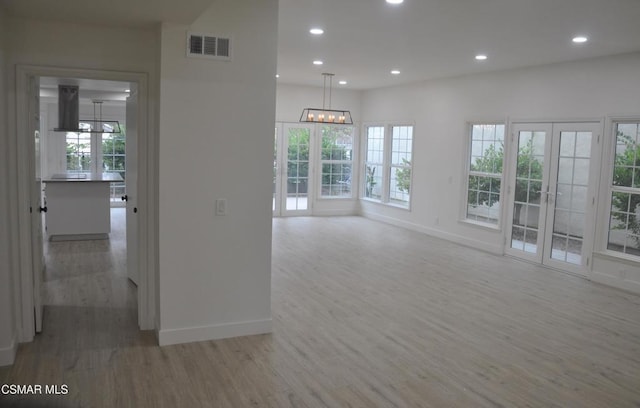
362;54;640;290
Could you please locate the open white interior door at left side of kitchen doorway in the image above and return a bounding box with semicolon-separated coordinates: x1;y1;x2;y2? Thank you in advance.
28;77;47;333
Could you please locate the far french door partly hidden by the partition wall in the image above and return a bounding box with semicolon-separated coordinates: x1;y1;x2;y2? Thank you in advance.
273;124;313;216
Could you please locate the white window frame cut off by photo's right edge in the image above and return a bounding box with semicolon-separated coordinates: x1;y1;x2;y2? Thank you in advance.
597;116;640;263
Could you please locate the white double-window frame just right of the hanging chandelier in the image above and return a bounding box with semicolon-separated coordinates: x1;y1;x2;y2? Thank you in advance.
360;123;416;211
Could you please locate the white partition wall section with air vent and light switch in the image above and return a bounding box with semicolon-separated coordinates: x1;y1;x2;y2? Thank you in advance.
159;0;278;344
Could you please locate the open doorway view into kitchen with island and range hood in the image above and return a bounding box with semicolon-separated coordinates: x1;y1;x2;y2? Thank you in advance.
34;77;137;333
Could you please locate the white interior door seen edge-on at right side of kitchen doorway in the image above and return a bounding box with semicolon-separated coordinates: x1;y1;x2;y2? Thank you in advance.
124;83;139;285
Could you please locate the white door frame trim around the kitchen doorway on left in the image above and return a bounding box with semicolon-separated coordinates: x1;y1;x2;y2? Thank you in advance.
10;65;157;342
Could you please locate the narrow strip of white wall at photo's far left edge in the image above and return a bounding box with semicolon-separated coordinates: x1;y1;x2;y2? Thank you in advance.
0;7;16;366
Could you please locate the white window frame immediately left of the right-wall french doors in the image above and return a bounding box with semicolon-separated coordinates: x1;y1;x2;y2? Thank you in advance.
460;120;508;231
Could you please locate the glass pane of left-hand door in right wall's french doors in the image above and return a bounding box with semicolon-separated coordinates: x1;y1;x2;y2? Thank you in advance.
511;131;546;254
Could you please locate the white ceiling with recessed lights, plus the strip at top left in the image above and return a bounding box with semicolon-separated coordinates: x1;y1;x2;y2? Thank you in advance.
0;0;640;89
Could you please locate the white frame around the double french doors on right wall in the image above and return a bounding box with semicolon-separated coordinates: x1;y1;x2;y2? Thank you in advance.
503;117;605;279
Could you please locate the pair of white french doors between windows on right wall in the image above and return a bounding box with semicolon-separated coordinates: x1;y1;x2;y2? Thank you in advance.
505;122;601;275
